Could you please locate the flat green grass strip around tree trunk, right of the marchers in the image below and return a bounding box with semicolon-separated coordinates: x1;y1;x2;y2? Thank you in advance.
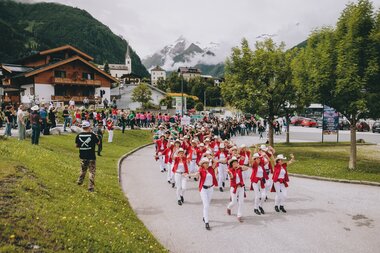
275;143;380;182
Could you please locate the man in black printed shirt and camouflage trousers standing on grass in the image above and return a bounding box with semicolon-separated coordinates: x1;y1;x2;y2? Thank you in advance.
75;121;99;192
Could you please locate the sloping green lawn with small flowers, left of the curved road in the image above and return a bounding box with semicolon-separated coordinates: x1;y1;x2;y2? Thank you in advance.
0;130;166;252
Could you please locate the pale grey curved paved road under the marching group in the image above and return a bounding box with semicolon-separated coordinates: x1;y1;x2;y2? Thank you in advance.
121;146;380;253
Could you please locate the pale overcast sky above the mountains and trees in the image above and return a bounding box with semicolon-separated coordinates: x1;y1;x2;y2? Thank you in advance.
27;0;380;58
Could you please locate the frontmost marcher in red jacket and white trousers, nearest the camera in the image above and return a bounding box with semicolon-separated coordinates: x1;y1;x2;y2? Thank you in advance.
192;157;218;230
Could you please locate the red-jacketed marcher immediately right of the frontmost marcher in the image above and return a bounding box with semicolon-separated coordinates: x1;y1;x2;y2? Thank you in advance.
227;157;248;222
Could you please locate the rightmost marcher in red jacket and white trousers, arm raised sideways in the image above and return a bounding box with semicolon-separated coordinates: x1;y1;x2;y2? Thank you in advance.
272;154;295;213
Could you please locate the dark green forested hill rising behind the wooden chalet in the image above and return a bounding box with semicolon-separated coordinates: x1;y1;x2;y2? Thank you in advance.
0;0;149;77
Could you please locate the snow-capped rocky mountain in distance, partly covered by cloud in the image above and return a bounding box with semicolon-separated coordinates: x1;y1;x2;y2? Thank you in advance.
142;36;224;74
